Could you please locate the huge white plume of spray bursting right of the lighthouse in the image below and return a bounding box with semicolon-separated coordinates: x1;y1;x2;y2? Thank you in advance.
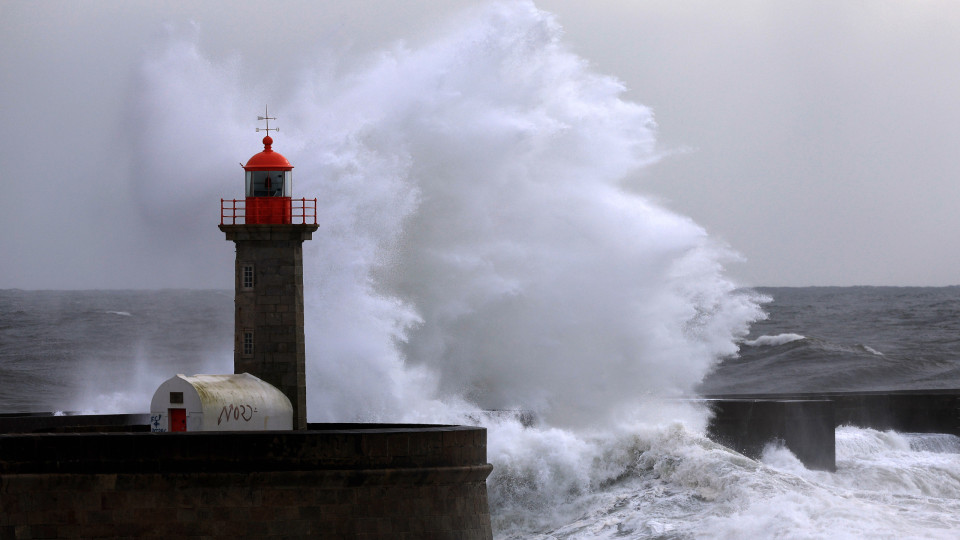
295;3;759;426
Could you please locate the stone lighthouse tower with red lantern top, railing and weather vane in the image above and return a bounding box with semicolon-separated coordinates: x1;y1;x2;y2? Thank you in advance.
220;112;317;429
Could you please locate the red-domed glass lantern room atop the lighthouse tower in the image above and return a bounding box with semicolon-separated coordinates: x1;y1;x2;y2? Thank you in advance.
243;135;293;225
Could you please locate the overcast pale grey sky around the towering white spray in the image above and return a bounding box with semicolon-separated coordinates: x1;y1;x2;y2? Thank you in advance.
0;0;960;289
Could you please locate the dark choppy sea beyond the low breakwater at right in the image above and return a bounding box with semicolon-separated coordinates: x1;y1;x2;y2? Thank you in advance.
702;287;960;393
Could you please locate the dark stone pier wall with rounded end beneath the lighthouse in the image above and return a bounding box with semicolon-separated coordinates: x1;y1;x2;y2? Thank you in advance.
0;417;492;540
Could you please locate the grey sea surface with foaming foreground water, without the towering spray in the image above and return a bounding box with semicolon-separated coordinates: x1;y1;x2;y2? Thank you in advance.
0;287;960;539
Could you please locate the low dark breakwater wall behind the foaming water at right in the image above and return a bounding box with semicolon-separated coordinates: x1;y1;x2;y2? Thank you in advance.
706;390;960;471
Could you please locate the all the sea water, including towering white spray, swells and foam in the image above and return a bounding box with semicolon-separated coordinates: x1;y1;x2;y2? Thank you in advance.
0;2;960;538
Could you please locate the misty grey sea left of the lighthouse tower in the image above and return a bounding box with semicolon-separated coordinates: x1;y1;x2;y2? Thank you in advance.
0;290;233;412
